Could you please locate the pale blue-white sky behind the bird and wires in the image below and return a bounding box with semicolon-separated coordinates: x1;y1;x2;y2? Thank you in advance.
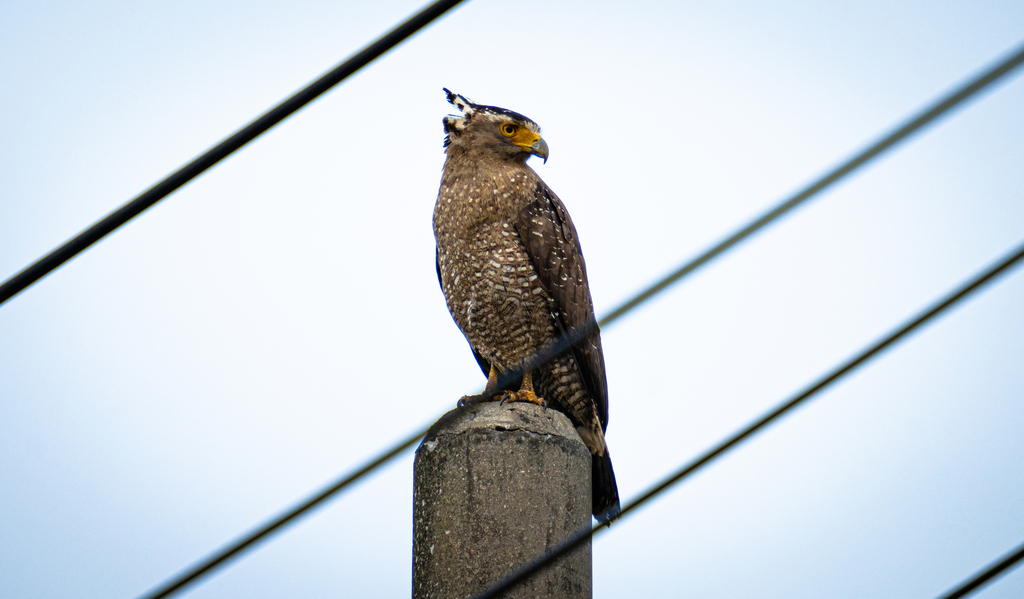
0;0;1024;599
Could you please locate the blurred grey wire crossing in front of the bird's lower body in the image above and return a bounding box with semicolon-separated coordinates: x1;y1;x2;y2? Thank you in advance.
132;36;1024;599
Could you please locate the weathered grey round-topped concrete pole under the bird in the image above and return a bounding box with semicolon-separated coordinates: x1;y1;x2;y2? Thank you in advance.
413;402;591;599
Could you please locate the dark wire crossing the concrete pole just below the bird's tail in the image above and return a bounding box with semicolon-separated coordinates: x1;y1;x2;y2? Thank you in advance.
473;238;1024;599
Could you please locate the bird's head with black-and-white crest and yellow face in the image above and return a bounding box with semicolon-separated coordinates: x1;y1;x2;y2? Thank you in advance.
443;89;548;162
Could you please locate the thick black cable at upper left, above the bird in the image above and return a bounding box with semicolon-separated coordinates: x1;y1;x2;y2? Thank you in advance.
0;0;463;305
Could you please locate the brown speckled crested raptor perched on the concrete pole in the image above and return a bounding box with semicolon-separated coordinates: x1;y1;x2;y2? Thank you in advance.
433;89;618;520
